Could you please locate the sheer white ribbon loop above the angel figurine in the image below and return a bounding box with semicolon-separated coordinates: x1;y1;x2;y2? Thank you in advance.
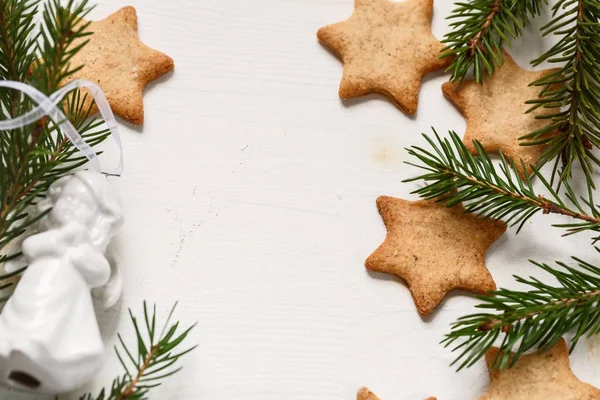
0;79;123;176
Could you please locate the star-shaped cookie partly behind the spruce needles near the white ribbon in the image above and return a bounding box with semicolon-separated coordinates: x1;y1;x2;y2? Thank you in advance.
62;7;174;125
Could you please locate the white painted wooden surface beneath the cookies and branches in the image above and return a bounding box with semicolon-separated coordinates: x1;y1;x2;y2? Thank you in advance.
0;0;600;400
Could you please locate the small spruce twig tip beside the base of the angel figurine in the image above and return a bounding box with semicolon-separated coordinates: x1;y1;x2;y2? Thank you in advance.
79;302;196;400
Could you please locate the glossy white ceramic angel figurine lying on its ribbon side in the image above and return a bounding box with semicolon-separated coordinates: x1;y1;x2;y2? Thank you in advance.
0;171;123;393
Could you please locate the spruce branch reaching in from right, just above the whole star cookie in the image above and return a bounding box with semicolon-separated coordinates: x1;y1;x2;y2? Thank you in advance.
404;130;600;240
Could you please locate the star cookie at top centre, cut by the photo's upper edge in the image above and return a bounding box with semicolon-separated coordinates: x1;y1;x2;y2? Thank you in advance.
317;0;450;114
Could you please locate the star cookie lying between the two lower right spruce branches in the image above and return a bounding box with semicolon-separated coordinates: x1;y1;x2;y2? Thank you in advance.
365;196;506;315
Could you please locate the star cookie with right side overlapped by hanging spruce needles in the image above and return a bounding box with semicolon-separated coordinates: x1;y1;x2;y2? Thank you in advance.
442;50;559;176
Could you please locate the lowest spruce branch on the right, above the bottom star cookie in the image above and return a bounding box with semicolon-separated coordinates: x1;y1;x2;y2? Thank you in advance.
442;255;600;370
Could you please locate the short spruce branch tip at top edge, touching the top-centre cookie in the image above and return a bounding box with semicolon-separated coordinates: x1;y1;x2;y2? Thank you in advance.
440;0;547;83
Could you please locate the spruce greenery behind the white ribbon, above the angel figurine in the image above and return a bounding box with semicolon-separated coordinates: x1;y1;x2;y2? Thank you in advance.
0;0;109;294
